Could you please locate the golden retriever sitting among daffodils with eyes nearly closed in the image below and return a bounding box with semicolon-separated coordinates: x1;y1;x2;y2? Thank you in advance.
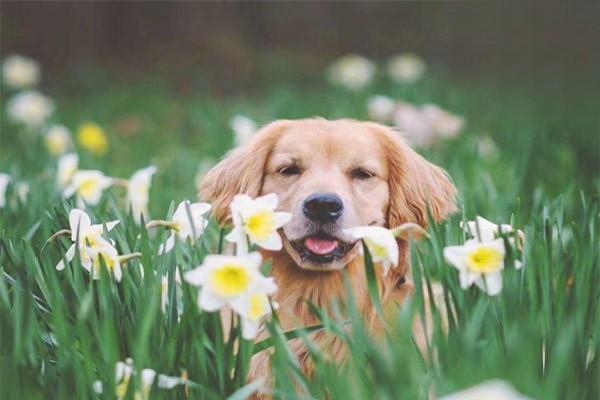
200;118;456;390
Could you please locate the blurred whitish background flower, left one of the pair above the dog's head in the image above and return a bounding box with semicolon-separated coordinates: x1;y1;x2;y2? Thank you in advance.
327;54;376;90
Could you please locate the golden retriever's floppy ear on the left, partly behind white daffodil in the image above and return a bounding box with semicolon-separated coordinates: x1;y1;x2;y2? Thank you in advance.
200;120;287;224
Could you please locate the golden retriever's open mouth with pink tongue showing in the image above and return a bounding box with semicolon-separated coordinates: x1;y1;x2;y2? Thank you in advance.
290;233;356;264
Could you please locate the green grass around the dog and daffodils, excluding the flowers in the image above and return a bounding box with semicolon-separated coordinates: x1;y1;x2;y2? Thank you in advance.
0;64;600;399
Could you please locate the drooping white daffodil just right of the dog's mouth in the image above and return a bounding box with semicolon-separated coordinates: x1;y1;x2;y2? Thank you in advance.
344;226;399;275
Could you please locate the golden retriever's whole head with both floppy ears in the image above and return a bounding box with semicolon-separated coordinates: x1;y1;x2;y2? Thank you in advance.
201;119;455;271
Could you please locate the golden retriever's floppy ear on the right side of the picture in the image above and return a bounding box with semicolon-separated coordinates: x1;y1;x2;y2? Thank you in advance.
369;123;456;228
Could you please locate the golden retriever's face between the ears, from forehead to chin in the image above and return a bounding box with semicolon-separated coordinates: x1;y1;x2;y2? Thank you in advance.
261;120;389;270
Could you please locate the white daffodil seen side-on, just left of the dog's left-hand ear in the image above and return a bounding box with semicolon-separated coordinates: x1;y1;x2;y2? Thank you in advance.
158;200;211;254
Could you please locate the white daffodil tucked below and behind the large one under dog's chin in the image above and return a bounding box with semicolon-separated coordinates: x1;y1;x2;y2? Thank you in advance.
230;275;277;340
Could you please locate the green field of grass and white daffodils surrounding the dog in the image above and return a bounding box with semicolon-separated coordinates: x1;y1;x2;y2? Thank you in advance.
0;54;600;399
